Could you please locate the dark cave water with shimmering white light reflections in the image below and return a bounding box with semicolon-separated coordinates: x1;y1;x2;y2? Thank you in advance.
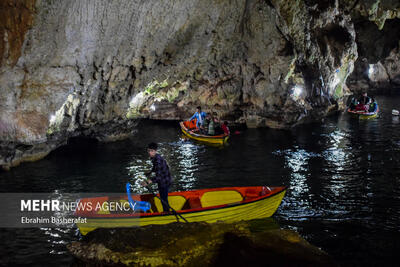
0;96;400;266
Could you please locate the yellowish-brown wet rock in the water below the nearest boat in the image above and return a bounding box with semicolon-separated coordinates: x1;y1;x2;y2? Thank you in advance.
67;221;335;266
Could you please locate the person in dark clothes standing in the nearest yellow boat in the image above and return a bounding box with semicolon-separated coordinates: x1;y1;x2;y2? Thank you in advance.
143;143;172;212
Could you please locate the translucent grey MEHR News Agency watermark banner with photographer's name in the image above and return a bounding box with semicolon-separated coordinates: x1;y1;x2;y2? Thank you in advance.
0;192;141;228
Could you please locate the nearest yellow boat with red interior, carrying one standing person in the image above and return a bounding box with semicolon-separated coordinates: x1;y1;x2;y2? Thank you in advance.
75;186;286;235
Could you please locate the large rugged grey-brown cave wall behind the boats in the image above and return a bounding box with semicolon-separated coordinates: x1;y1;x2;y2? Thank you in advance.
0;0;372;168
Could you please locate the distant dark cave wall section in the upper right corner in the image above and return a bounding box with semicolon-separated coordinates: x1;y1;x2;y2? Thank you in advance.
348;0;400;94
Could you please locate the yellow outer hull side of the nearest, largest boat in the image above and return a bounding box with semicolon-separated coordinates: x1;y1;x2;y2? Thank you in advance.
77;187;286;235
